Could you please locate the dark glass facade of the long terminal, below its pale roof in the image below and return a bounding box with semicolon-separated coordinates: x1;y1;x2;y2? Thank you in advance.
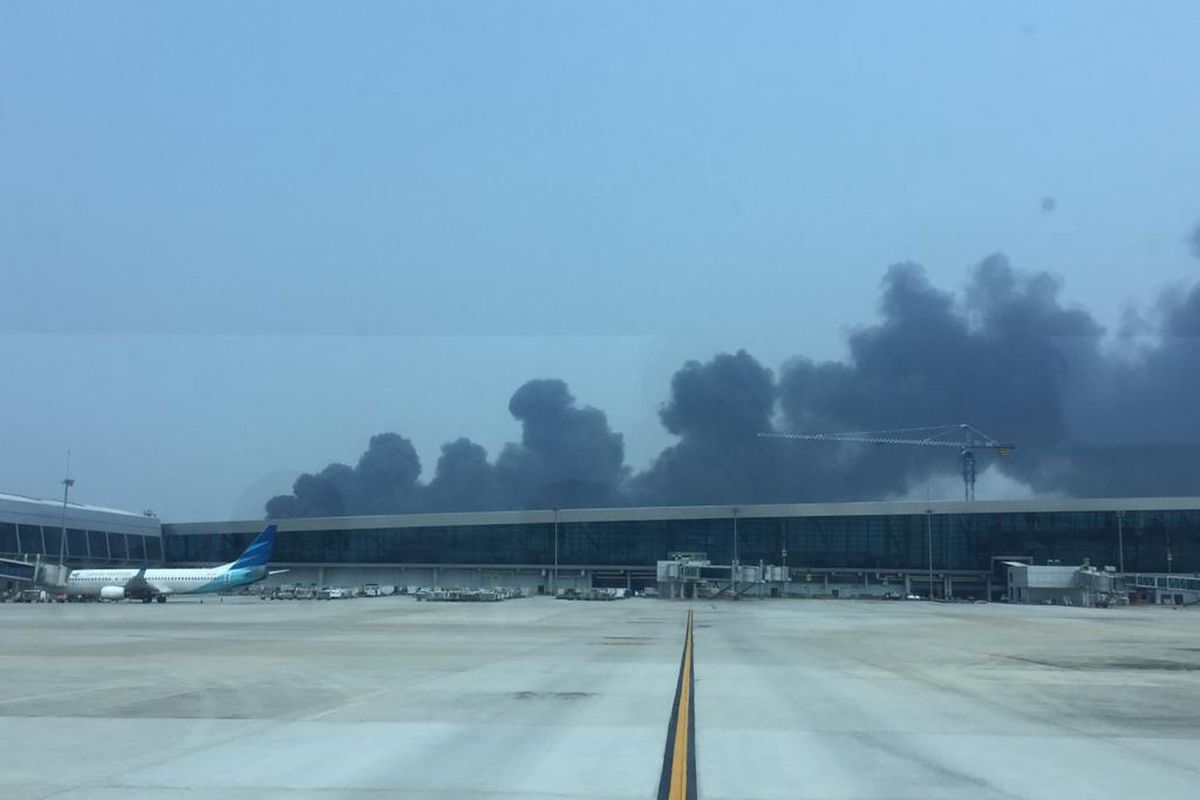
166;510;1200;572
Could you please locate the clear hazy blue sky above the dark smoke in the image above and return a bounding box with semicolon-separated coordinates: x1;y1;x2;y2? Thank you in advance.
0;1;1200;519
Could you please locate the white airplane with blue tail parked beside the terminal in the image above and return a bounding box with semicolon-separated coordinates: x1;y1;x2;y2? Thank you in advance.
67;524;279;603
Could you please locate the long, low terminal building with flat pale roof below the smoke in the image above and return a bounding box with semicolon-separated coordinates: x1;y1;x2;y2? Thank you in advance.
162;498;1200;599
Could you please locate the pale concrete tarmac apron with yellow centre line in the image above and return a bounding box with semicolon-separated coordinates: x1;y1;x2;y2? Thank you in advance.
0;597;1200;800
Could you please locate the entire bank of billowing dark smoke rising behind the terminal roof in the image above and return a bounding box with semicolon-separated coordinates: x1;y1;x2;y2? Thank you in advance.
266;236;1200;517
